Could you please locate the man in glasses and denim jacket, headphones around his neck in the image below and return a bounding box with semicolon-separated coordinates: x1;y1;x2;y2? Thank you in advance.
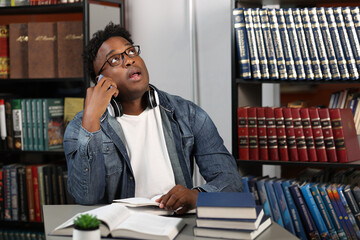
64;23;242;214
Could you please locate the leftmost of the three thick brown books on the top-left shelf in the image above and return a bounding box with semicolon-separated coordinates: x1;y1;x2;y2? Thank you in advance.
9;23;29;79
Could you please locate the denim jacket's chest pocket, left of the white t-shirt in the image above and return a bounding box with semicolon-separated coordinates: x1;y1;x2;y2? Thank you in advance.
103;142;123;175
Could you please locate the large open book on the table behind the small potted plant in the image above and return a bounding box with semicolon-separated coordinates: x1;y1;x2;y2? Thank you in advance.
50;203;185;240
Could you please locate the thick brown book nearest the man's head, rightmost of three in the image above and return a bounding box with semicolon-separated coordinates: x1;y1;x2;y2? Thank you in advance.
57;21;84;78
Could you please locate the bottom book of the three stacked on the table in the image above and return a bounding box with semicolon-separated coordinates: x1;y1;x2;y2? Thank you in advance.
194;217;271;239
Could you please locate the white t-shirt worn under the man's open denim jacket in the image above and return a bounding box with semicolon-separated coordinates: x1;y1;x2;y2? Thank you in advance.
117;106;175;198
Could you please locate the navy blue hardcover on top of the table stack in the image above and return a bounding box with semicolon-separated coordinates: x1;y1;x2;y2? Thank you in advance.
196;192;257;219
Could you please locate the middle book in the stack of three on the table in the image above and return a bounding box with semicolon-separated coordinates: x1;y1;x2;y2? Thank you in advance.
196;206;264;230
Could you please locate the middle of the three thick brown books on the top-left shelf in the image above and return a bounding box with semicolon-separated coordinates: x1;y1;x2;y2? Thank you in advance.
28;22;57;78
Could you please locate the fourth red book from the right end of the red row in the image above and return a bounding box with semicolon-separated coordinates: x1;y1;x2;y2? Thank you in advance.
300;108;317;162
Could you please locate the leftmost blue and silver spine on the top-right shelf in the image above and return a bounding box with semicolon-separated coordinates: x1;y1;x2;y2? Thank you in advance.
233;8;251;79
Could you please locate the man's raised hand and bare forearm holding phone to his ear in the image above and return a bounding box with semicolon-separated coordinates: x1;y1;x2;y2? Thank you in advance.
82;76;119;132
